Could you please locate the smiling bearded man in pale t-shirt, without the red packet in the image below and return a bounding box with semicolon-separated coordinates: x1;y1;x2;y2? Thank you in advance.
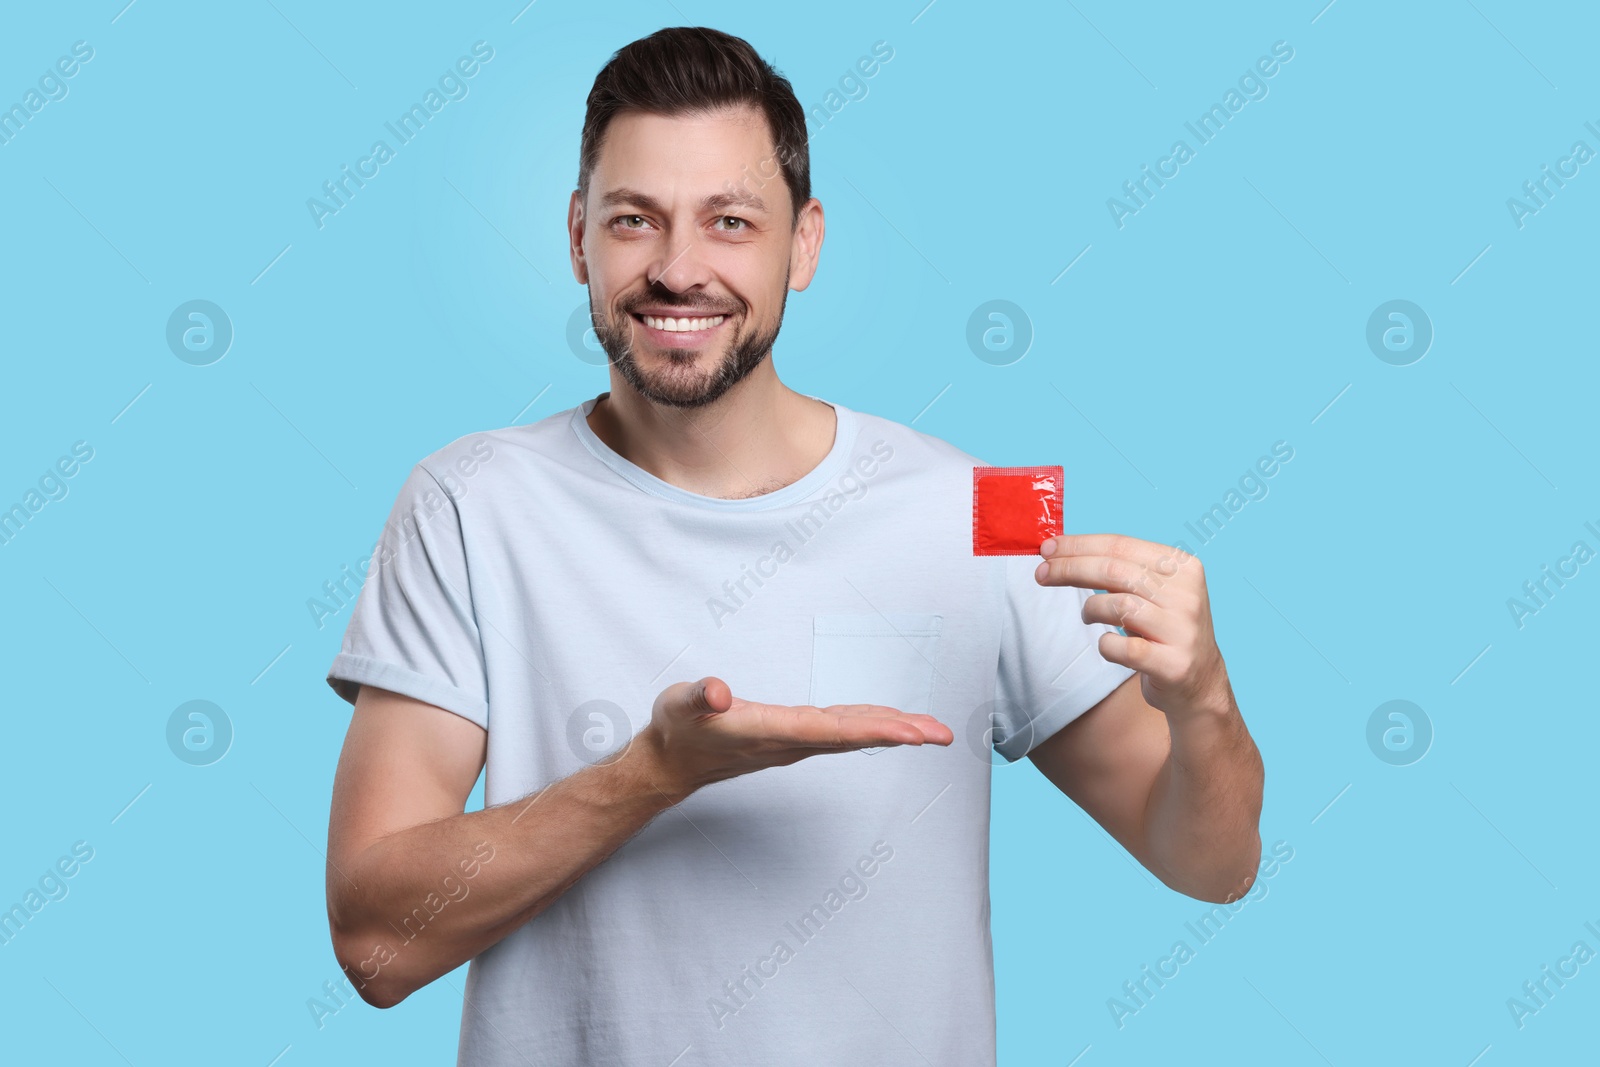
328;29;1262;1067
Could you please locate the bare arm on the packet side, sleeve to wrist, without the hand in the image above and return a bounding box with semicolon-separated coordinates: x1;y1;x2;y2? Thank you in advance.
1029;675;1262;902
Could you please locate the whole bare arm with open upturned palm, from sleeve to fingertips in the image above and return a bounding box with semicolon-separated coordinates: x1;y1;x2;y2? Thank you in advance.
328;678;954;1008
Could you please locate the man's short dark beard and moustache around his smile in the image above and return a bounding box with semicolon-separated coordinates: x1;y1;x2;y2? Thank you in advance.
589;275;789;408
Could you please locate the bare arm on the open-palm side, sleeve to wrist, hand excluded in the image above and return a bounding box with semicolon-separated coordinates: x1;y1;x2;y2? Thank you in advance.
328;686;685;1008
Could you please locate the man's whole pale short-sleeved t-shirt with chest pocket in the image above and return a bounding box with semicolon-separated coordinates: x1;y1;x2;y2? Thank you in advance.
328;400;1133;1067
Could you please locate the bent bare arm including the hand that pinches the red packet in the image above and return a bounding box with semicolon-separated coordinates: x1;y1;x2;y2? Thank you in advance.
1029;534;1264;902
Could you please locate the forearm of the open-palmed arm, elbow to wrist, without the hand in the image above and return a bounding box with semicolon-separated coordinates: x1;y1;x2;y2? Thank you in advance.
328;729;690;1008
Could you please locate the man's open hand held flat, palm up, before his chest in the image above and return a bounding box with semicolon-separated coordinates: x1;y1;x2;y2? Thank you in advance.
634;677;955;795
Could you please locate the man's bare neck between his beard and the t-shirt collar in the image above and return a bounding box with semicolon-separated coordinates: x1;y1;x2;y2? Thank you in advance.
589;358;835;499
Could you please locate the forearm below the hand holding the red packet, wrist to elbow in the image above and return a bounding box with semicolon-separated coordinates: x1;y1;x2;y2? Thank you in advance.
1146;694;1262;902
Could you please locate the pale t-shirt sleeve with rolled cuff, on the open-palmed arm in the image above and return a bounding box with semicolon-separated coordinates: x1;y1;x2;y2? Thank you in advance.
328;464;490;729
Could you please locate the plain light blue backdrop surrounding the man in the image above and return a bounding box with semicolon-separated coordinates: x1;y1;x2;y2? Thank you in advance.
0;0;1600;1067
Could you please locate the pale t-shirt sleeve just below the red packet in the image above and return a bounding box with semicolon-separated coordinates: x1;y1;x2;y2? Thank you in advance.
994;555;1134;761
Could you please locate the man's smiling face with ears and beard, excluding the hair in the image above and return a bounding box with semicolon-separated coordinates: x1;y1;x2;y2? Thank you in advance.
568;107;822;408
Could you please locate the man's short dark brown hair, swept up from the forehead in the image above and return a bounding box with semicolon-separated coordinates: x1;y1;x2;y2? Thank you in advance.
578;26;811;222
